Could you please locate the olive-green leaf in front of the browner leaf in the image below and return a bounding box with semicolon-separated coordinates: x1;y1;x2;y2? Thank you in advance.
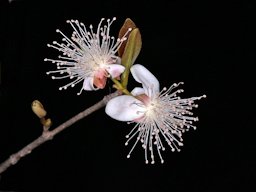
121;28;142;88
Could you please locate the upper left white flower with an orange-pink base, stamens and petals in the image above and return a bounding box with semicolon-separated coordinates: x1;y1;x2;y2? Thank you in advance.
44;17;131;95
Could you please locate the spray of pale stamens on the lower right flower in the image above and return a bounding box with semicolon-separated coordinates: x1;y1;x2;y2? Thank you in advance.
126;82;206;164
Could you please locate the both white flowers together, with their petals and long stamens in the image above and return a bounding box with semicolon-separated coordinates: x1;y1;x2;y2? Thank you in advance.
45;18;206;164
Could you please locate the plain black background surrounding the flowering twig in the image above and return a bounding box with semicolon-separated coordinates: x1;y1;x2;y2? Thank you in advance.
0;0;256;192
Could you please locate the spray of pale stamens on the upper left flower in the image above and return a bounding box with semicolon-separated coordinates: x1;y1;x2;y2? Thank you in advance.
44;17;130;95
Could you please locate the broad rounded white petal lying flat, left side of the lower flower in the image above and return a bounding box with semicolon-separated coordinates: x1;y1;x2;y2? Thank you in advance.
105;95;145;121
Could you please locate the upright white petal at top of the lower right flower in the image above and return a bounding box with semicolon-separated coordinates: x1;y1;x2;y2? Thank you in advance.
131;64;159;98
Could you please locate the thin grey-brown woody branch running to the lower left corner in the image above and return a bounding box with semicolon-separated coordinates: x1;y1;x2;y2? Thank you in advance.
0;91;120;174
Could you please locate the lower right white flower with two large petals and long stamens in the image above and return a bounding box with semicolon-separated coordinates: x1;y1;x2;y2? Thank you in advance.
105;64;206;164
